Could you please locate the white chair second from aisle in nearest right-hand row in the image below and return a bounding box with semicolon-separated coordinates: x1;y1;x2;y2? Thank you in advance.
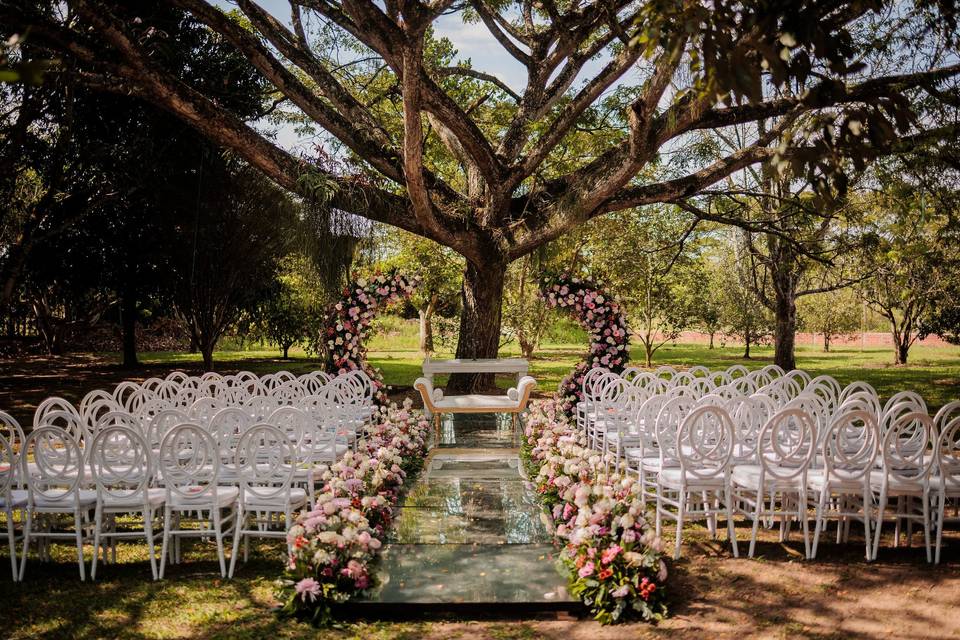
731;408;817;558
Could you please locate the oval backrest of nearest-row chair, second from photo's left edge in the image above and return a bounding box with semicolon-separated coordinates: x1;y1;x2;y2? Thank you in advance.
20;424;84;503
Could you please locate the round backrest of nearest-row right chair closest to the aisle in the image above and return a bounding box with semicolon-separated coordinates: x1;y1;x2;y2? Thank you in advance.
676;405;734;479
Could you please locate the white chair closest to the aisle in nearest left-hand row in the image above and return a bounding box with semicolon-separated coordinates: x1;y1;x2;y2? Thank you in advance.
228;424;307;578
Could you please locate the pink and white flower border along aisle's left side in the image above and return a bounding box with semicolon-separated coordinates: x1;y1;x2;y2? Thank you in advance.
278;399;430;624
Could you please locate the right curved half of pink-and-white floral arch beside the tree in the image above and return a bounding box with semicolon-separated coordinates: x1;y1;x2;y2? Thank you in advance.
540;274;630;414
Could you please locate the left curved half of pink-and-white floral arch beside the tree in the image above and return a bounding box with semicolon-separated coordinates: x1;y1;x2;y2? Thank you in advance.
321;273;417;405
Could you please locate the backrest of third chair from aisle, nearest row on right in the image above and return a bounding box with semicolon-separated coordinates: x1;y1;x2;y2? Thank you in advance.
821;409;880;482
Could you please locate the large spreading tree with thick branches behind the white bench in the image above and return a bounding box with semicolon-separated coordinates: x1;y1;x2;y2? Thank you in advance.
7;0;960;387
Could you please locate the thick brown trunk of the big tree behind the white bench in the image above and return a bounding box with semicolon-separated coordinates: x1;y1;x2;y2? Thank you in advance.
447;258;507;393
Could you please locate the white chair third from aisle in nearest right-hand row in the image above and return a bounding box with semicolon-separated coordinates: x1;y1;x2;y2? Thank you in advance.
807;410;880;561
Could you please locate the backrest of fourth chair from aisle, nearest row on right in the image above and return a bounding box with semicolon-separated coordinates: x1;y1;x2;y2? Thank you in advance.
881;411;937;482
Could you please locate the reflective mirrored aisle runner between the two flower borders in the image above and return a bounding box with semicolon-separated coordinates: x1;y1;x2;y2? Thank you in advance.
358;414;570;608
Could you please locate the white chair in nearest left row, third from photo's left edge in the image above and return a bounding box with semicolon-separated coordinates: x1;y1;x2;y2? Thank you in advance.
90;424;166;580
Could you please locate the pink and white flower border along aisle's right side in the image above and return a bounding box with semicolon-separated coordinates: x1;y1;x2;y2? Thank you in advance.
521;401;667;624
